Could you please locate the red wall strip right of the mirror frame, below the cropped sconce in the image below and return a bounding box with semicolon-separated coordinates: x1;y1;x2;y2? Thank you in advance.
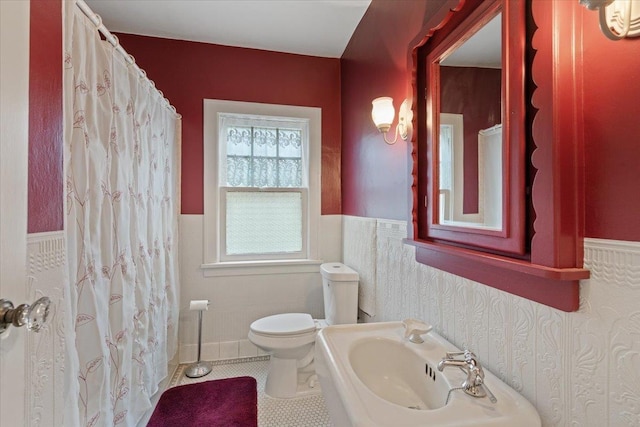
576;10;640;241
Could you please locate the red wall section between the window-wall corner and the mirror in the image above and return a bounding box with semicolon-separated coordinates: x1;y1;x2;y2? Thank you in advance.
342;0;444;220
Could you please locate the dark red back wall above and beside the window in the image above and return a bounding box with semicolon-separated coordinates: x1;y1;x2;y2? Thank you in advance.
118;34;341;214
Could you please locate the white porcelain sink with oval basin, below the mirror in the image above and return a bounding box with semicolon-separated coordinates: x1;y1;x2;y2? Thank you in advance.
315;322;541;427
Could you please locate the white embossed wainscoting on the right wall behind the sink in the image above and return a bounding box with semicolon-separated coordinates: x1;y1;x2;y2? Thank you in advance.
343;216;640;427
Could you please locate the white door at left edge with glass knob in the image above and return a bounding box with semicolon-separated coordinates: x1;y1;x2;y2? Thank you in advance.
0;0;30;426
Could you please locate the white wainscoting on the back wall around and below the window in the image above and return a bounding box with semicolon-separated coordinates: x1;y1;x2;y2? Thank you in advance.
179;215;342;363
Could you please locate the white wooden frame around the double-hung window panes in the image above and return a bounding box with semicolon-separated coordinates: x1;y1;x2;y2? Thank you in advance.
201;99;322;276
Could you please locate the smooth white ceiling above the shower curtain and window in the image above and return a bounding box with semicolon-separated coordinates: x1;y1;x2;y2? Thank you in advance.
85;0;371;58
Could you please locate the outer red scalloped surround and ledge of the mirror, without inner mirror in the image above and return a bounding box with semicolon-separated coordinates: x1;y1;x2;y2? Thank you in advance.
407;0;589;311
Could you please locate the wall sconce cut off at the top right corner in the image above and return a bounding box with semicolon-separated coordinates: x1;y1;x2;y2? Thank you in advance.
580;0;640;40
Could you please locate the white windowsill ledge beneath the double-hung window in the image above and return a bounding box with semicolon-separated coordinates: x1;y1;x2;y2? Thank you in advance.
200;259;323;277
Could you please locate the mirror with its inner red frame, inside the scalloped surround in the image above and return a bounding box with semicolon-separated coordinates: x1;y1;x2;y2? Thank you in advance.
414;0;528;257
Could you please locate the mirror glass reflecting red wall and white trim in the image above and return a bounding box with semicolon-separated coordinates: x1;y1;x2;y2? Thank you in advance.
437;13;503;230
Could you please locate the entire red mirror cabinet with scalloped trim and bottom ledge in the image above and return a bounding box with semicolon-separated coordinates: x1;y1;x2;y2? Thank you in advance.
406;0;589;311
